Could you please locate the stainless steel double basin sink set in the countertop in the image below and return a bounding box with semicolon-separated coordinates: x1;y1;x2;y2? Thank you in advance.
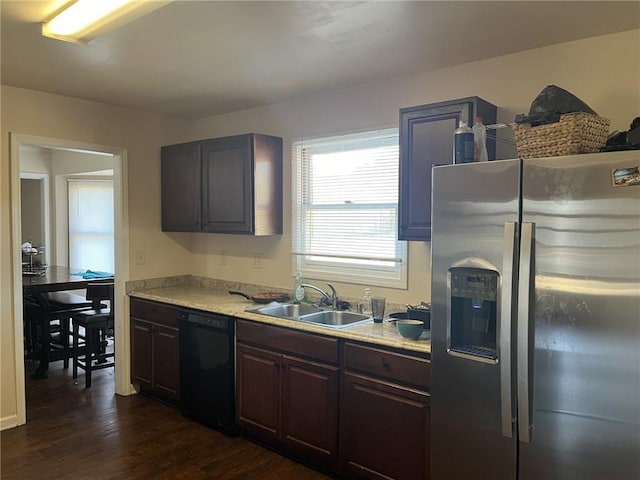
250;303;371;328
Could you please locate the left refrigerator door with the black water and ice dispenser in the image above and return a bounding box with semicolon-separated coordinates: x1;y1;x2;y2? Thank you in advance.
431;160;520;480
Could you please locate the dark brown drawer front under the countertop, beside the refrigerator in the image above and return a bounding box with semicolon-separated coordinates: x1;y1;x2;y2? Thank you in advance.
344;342;431;390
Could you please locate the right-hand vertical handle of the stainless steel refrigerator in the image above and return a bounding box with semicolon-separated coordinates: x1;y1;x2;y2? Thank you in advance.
517;223;535;443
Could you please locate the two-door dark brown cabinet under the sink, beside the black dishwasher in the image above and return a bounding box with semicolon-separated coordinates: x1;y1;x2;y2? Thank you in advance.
236;320;339;471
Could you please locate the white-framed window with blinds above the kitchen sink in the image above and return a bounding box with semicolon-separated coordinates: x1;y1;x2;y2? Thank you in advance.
292;128;407;288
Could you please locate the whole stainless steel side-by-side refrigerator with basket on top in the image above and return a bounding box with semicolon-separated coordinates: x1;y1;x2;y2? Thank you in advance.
431;151;640;480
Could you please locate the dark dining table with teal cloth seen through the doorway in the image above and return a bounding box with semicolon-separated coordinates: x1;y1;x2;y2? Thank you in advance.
22;265;114;380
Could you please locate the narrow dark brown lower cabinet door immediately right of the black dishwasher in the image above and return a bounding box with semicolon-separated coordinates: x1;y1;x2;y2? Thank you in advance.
236;343;281;440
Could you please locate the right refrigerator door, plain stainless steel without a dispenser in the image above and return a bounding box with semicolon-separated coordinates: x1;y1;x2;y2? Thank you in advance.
520;152;640;480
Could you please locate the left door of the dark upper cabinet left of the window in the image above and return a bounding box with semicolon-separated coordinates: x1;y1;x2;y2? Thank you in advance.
160;142;202;232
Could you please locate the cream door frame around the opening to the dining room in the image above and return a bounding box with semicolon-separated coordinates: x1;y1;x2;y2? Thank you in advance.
10;133;135;425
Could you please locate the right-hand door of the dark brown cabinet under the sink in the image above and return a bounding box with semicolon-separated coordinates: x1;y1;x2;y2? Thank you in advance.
281;356;339;468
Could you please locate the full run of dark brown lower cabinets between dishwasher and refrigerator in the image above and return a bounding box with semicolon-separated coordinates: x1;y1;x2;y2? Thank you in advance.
236;319;431;480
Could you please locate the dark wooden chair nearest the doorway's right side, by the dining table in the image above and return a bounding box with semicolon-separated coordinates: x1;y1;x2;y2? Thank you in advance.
71;282;115;388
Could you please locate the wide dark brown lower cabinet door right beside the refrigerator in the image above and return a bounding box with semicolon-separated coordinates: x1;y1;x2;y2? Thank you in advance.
340;373;430;480
